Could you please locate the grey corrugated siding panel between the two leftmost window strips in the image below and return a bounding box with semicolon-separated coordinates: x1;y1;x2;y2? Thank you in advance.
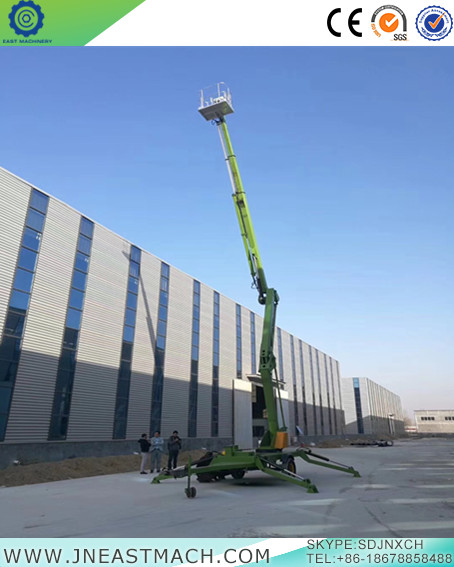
6;199;80;442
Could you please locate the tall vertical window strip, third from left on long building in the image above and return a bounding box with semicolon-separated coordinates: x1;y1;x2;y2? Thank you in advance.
112;244;142;439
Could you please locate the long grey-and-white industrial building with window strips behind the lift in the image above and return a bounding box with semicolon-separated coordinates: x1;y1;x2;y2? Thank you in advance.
0;168;348;466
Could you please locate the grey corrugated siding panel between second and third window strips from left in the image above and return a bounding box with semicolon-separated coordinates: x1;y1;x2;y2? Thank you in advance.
67;225;129;441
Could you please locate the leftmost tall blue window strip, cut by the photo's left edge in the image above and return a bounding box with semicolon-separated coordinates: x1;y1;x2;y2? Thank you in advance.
0;189;49;441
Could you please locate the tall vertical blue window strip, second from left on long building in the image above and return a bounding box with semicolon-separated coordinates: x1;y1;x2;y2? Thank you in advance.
48;217;93;441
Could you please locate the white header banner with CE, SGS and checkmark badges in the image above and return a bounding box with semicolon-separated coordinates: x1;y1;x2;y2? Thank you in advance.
88;0;454;47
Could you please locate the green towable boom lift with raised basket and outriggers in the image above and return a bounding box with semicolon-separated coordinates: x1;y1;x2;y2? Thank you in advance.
152;83;360;498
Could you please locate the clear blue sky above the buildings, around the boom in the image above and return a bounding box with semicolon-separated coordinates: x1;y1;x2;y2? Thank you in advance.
0;47;454;418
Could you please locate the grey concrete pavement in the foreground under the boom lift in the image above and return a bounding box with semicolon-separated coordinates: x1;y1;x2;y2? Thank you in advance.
0;438;454;538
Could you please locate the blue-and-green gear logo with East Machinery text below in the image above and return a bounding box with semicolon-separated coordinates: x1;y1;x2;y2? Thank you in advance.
2;0;52;45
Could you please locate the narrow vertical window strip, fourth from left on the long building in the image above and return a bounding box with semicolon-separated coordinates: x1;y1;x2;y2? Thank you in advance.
150;262;170;433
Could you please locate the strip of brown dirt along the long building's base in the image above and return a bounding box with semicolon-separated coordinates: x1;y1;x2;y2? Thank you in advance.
0;451;204;487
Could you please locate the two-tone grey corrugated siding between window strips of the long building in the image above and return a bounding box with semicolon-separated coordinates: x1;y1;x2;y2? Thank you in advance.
0;169;404;450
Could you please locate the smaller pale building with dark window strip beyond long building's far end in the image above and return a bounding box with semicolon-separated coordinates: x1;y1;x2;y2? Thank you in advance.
341;378;404;436
